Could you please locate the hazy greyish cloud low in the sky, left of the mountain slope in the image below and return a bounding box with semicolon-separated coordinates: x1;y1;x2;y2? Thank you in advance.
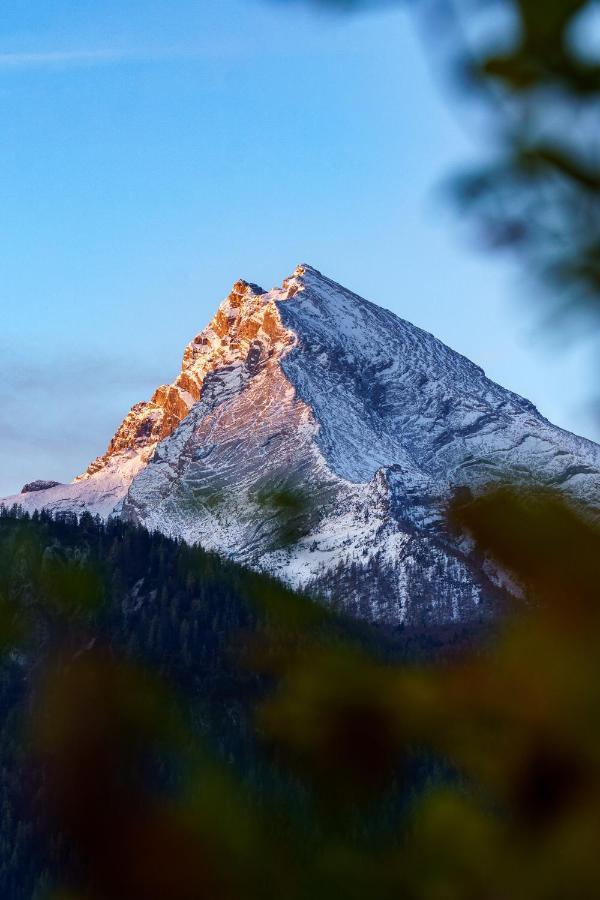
0;343;168;497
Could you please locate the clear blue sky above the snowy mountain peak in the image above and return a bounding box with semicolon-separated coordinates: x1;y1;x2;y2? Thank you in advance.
0;0;594;495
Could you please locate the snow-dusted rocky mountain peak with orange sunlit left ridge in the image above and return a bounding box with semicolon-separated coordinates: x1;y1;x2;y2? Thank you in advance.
4;265;600;623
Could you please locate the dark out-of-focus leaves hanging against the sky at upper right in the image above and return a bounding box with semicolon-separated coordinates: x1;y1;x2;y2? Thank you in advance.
279;0;600;339
